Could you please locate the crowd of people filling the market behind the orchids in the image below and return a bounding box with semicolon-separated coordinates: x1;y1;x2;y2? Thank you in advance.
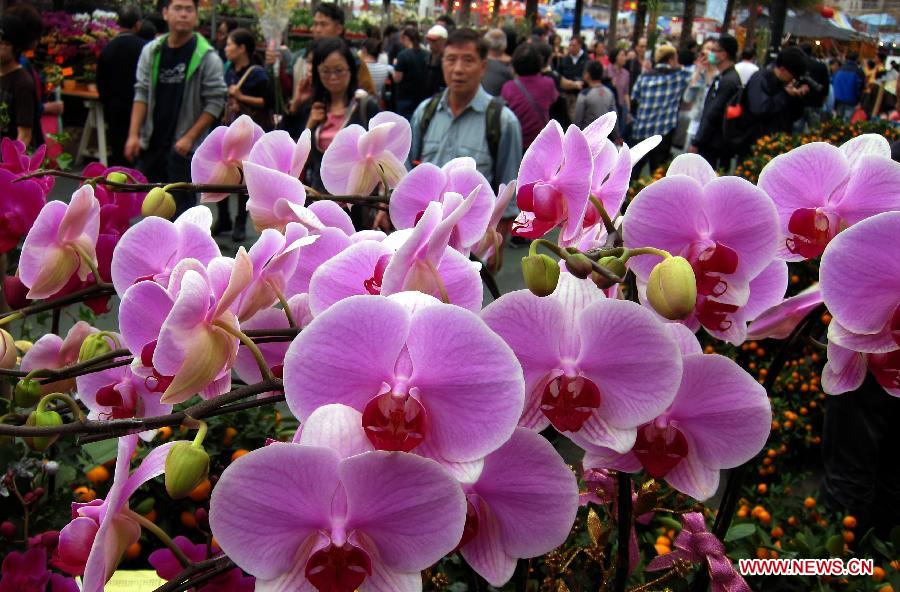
0;0;897;241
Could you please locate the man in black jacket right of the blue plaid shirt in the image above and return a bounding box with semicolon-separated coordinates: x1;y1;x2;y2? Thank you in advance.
689;35;741;170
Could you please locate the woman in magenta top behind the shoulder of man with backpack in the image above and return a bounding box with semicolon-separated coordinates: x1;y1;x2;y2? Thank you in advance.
500;43;559;149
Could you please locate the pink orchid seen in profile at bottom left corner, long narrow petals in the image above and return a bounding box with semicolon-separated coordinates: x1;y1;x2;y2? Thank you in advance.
52;435;175;592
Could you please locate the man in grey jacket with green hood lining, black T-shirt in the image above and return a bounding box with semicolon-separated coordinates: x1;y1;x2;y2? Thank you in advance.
125;0;227;216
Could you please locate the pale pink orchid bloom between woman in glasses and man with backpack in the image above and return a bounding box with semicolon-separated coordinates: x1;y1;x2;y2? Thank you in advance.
322;111;412;195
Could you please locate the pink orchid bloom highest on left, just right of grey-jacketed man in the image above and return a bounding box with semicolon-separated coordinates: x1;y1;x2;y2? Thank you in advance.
191;115;263;202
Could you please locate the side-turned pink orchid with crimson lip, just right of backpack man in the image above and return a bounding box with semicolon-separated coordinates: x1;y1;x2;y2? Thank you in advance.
513;120;593;241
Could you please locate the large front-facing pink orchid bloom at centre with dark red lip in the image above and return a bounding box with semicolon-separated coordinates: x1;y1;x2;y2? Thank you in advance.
284;292;524;462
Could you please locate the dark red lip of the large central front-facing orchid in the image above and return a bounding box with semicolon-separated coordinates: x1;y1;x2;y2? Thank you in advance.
362;393;426;452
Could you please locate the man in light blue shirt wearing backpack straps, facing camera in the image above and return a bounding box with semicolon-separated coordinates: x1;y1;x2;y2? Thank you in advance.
408;29;522;192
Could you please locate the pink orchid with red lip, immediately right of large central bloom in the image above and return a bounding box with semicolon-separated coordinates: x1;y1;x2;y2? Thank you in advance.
481;273;681;452
